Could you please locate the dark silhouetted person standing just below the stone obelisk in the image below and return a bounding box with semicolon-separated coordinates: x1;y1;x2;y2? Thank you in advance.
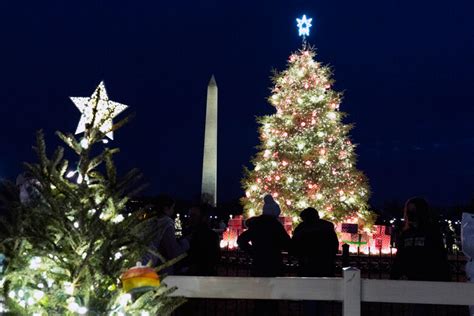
186;205;220;276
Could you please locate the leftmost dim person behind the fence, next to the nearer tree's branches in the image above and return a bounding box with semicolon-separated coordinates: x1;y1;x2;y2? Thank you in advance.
141;195;189;274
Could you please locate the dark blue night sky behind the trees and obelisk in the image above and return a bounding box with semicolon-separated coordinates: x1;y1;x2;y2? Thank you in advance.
0;0;474;205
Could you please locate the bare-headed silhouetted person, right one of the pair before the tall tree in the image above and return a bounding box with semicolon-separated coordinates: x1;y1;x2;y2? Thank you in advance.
292;207;339;277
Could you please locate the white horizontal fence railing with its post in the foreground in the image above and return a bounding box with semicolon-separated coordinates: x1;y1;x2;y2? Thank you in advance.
164;268;474;316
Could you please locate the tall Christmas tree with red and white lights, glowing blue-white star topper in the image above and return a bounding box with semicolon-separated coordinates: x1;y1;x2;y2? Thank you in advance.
242;16;373;227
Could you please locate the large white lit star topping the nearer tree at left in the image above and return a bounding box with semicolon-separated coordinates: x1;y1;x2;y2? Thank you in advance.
70;81;128;139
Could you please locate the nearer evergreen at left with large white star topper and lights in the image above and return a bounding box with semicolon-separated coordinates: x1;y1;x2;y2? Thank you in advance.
0;83;182;315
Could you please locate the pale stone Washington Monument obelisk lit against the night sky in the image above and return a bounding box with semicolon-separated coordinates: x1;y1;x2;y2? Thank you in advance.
201;75;217;206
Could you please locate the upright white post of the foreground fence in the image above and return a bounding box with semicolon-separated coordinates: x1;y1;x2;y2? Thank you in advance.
342;267;361;316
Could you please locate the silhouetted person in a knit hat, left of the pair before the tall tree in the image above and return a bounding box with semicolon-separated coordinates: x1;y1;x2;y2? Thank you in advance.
237;195;290;277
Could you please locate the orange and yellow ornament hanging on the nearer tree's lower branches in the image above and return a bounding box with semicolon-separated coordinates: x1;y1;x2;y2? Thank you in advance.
120;262;160;292
